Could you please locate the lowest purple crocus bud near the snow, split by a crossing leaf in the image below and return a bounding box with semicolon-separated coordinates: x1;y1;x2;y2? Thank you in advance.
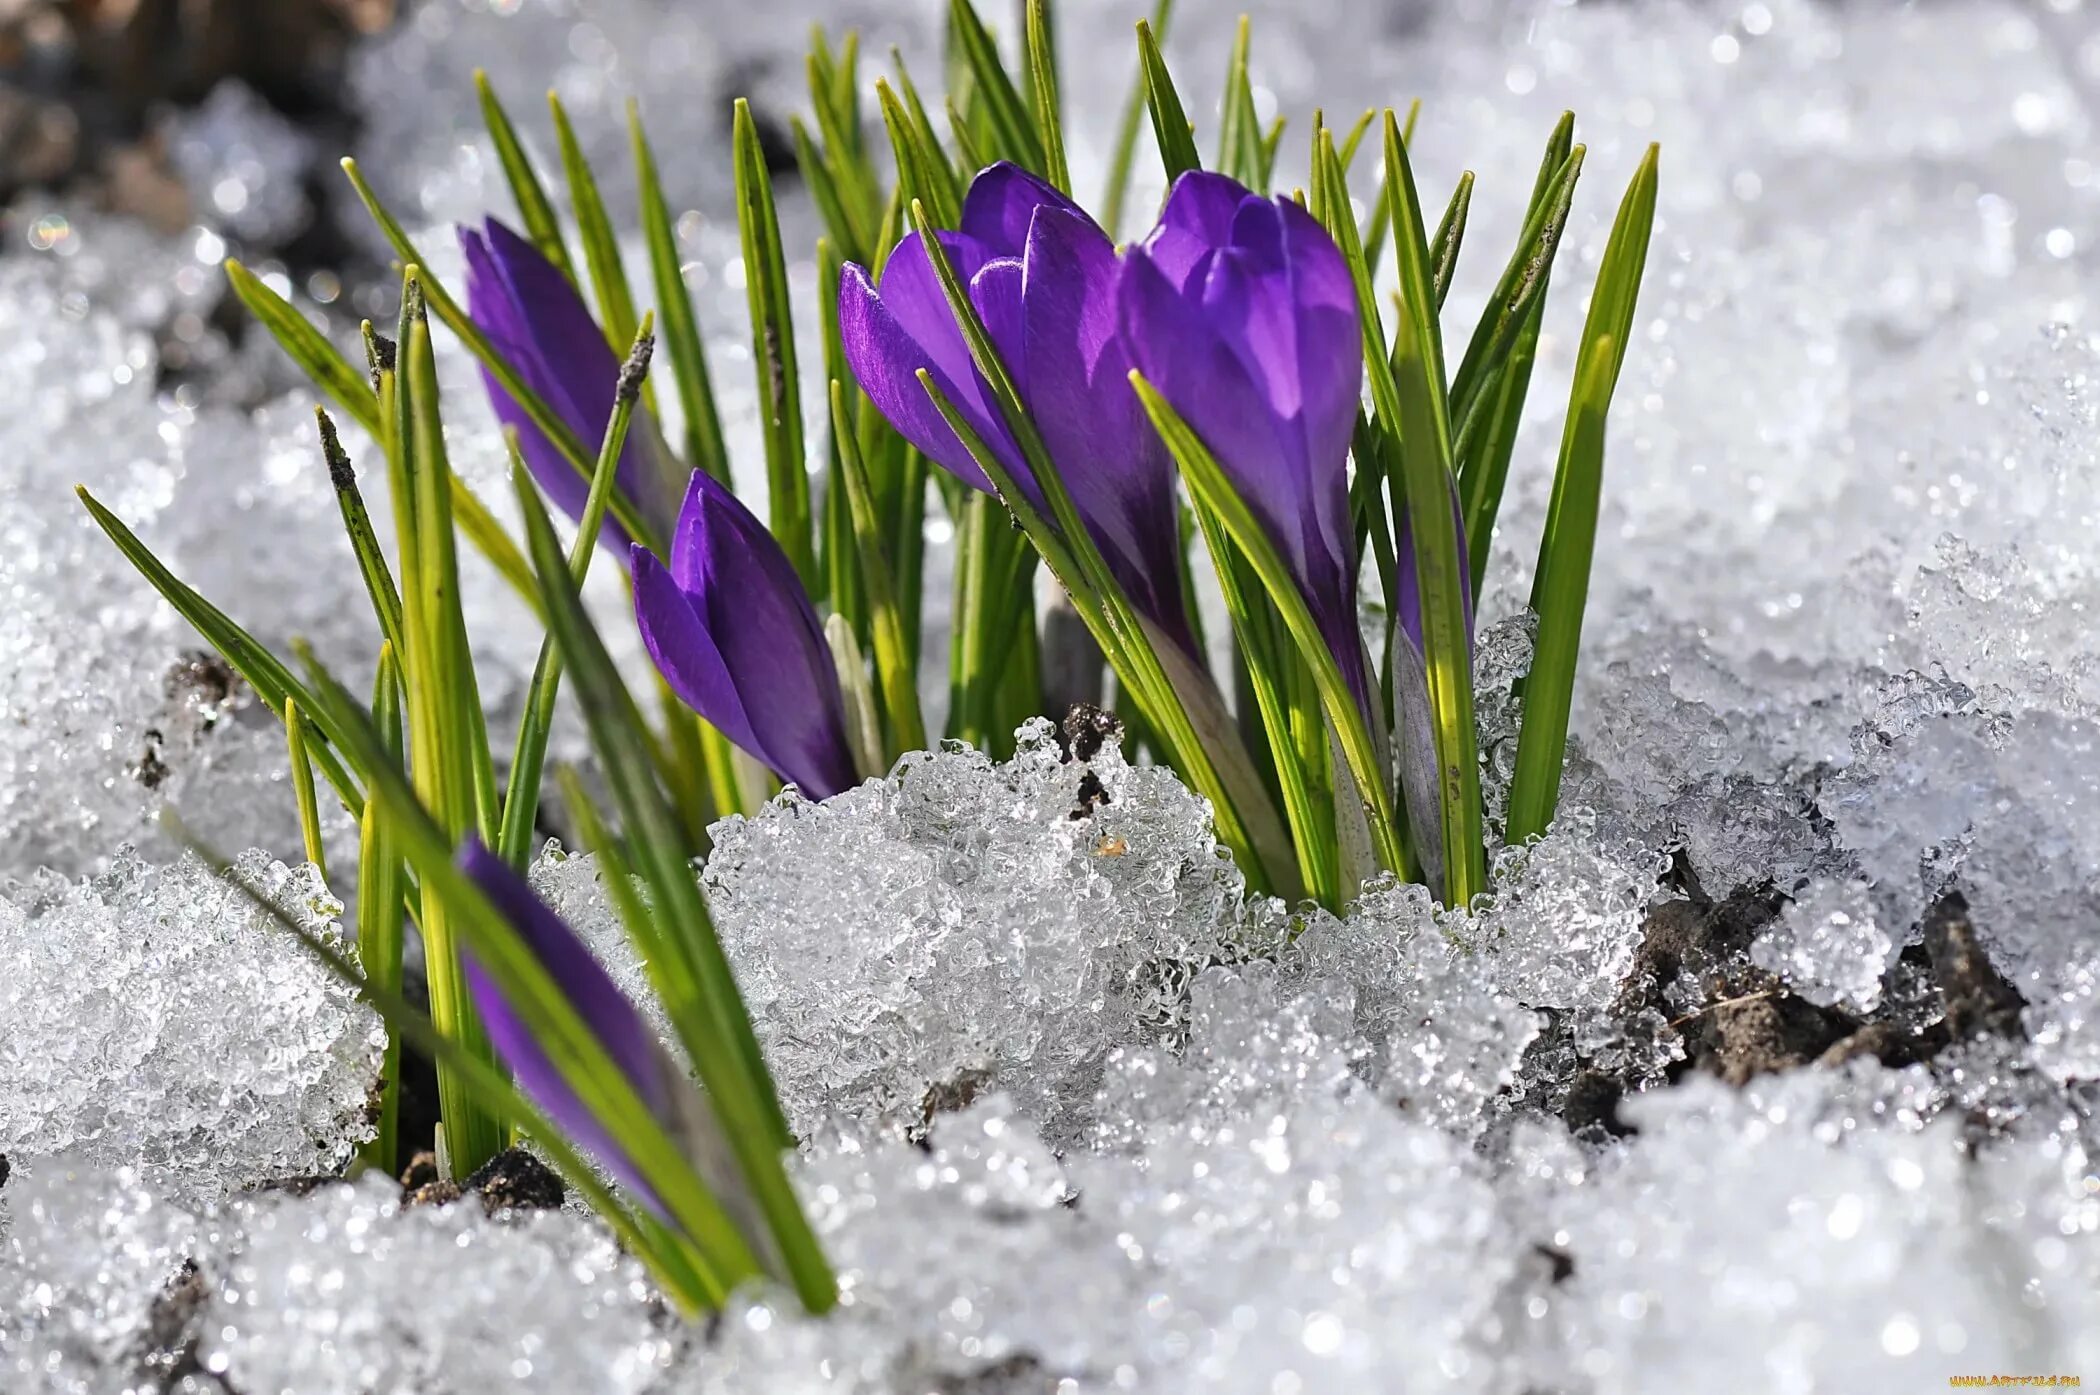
458;838;685;1214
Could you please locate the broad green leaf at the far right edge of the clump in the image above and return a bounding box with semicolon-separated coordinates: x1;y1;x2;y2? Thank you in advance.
1508;145;1659;842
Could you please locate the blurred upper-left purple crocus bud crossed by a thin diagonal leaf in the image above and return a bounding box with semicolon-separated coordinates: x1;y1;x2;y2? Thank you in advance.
460;218;685;546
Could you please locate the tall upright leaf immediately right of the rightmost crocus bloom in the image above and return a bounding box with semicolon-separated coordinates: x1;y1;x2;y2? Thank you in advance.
1369;111;1487;905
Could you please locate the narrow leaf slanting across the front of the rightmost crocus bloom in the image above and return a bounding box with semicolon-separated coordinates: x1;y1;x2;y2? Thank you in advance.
1130;370;1407;891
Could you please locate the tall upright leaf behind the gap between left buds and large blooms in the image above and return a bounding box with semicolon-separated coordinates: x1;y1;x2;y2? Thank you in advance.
735;97;823;590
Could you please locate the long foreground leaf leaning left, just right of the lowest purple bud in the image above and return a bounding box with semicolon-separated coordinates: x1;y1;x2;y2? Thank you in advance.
515;471;838;1313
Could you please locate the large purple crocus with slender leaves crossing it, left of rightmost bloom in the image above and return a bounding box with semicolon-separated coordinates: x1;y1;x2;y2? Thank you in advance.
838;162;1195;651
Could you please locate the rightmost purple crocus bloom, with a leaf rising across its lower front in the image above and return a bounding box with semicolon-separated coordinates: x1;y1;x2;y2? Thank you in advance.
1115;170;1371;712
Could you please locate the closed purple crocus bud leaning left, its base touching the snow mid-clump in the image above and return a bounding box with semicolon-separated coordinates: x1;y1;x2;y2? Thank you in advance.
632;471;857;798
